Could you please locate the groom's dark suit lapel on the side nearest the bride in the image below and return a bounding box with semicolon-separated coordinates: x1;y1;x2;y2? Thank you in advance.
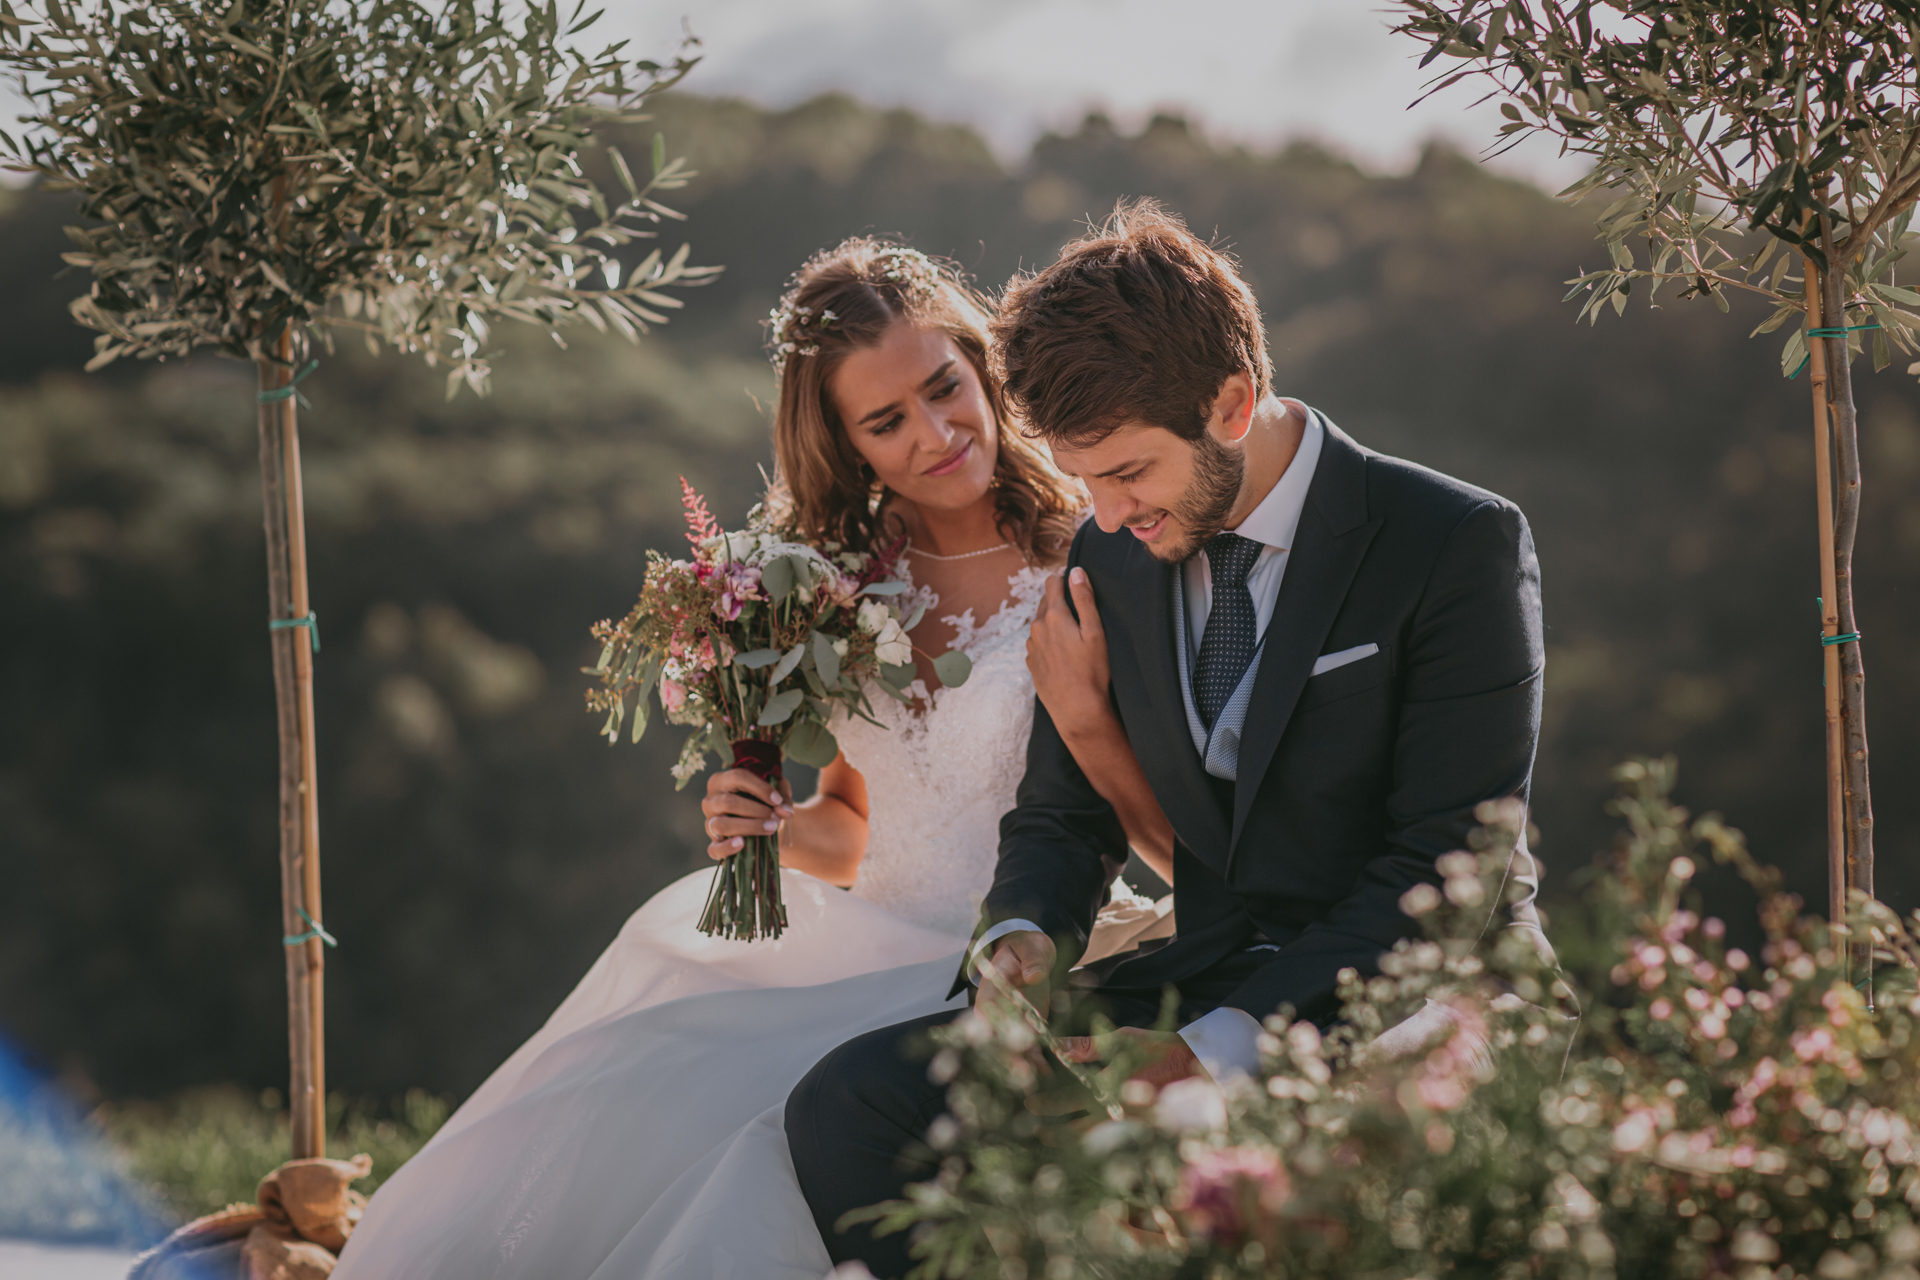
1127;533;1227;871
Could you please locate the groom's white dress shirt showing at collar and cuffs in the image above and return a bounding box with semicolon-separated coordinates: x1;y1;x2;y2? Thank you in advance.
968;405;1327;1079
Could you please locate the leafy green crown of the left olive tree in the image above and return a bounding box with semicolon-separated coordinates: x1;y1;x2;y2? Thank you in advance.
0;0;712;395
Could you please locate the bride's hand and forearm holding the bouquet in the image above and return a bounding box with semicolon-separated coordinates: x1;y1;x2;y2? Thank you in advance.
701;756;868;889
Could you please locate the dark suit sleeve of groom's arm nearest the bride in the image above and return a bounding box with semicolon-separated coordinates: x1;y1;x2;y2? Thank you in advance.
956;522;1127;971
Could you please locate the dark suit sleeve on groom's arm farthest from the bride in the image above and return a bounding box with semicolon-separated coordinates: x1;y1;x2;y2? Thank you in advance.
1223;499;1544;1021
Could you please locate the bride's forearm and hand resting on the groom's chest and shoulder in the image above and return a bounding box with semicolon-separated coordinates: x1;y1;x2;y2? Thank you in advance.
1027;570;1173;885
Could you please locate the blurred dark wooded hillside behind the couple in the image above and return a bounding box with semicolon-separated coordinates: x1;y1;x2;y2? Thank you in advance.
0;98;1920;1096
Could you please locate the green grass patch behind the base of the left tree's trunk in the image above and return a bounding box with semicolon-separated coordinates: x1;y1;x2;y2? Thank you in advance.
96;1086;451;1222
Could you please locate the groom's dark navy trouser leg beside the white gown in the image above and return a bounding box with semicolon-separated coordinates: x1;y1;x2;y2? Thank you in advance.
787;1011;958;1280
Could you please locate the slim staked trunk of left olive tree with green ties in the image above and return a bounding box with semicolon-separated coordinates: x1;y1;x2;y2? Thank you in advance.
259;332;326;1159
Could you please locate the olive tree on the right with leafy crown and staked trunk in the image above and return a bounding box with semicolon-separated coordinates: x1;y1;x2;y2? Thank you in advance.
1396;0;1920;932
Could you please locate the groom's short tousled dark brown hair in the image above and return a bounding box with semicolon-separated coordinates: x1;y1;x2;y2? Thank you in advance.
993;200;1273;447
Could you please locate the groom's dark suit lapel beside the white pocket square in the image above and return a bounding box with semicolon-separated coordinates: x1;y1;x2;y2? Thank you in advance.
1229;418;1380;858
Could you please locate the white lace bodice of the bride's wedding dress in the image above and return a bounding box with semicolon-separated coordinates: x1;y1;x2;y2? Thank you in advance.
833;568;1046;936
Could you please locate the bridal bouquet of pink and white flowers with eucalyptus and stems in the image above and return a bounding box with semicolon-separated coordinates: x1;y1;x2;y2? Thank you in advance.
586;480;972;940
